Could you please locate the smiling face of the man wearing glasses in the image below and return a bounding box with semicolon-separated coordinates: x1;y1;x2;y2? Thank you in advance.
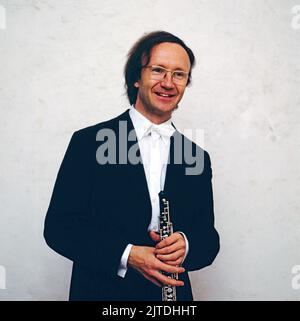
135;42;191;124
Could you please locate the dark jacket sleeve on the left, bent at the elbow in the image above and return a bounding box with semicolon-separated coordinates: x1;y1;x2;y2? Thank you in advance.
44;131;130;274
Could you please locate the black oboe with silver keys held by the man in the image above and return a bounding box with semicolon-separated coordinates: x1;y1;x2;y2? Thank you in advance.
158;191;178;301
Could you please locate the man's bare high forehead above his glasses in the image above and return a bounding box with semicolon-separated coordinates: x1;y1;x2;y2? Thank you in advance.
149;42;191;70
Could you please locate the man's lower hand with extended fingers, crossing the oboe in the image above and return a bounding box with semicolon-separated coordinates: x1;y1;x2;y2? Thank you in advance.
128;245;185;286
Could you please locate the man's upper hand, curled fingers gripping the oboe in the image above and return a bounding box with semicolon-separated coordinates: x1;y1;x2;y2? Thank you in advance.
154;232;186;266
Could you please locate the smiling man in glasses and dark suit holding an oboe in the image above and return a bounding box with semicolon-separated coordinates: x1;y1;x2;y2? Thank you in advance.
44;31;219;300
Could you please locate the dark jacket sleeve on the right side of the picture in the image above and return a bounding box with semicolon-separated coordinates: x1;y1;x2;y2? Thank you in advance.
183;152;220;271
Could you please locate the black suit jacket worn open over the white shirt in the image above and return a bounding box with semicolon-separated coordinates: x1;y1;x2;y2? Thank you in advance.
44;110;219;300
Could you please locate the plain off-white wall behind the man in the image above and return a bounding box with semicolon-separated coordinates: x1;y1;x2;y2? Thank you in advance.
0;0;300;300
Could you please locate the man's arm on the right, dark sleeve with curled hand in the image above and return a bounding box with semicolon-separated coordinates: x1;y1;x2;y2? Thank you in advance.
153;152;220;271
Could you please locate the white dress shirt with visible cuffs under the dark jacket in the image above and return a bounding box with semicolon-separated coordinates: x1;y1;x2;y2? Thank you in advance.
118;106;188;277
